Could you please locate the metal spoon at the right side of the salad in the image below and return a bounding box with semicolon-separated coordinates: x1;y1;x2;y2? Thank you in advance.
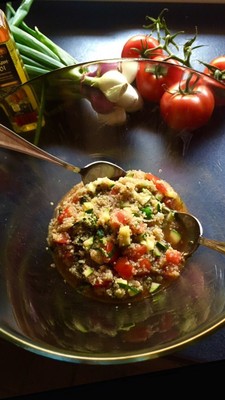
175;212;225;257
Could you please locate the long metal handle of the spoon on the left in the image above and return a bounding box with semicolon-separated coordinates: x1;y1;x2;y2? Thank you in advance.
0;124;80;173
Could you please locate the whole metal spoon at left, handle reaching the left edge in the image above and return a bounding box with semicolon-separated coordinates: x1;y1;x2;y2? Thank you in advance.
0;124;126;184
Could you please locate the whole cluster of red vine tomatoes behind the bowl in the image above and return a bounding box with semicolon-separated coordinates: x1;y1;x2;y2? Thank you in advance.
121;34;225;132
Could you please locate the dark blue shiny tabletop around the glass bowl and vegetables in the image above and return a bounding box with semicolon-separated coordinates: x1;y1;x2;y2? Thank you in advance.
2;1;225;368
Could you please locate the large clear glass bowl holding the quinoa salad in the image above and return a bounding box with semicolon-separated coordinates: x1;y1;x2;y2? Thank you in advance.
0;59;225;364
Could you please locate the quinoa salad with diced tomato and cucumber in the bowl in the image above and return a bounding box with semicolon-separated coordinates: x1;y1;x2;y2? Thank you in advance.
47;170;186;300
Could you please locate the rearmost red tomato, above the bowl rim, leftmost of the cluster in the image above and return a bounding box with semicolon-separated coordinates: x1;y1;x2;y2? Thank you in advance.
121;34;163;58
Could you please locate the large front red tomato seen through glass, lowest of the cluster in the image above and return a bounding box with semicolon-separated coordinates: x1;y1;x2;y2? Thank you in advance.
160;84;215;132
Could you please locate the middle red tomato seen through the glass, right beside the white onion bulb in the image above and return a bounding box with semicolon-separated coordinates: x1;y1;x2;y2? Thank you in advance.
136;56;184;103
